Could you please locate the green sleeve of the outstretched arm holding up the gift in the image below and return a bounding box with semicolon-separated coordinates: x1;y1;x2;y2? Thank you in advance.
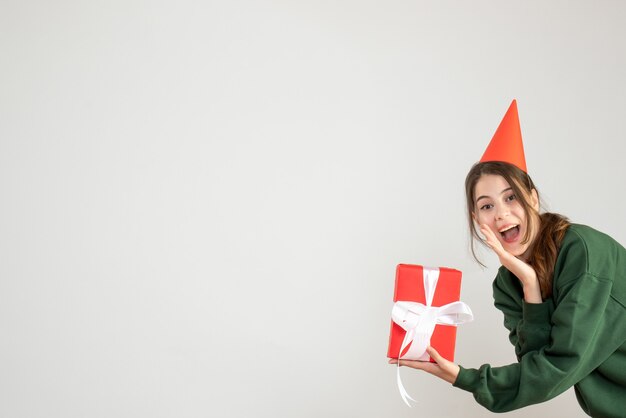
454;272;626;412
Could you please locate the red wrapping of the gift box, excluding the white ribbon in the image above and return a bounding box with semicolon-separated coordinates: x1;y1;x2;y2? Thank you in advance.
387;264;462;362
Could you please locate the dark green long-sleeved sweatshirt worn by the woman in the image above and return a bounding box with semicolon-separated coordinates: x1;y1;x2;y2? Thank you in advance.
454;225;626;417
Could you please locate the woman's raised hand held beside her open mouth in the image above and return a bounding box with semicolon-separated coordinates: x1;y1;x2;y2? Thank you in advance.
480;224;543;303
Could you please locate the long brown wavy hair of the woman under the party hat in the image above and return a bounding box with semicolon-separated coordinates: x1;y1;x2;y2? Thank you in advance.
465;161;570;299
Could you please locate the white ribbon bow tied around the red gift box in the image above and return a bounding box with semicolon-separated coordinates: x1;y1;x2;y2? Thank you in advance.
391;267;474;407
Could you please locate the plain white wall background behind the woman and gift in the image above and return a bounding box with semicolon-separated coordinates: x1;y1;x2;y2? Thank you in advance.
0;0;626;418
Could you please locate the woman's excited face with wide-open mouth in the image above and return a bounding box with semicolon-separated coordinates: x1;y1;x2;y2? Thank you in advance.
472;174;539;259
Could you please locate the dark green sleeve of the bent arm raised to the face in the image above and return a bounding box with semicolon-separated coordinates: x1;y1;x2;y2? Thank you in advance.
493;273;552;361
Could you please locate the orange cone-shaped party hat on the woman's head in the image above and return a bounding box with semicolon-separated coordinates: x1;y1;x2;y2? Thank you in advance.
480;99;528;173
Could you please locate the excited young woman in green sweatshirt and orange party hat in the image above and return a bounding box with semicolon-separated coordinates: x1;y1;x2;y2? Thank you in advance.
390;101;626;417
